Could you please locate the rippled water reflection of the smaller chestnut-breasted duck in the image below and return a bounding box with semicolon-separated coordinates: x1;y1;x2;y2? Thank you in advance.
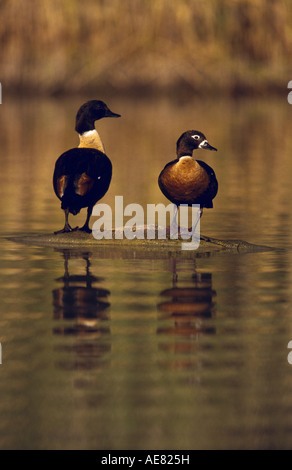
157;258;216;369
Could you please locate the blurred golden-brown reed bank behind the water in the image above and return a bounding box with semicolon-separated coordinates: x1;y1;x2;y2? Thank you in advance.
0;0;292;96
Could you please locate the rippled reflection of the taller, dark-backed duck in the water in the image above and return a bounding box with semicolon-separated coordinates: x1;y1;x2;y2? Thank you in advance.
52;250;110;369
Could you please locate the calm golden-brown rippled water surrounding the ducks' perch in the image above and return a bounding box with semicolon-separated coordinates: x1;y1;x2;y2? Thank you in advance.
0;93;292;450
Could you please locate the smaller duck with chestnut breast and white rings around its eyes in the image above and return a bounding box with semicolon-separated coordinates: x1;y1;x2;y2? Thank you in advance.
158;130;218;233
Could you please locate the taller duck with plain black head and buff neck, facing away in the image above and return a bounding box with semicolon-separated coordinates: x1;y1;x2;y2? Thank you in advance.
53;100;121;234
